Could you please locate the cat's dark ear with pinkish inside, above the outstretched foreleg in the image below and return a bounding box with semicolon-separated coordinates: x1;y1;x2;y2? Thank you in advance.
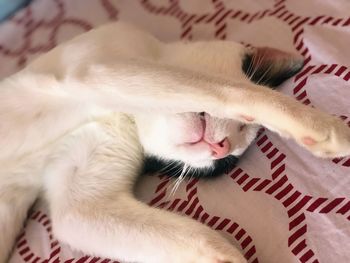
242;47;304;88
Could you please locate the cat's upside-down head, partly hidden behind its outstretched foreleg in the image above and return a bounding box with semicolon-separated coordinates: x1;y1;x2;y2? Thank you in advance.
136;42;303;177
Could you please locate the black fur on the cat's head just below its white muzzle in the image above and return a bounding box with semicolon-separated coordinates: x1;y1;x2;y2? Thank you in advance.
143;155;238;178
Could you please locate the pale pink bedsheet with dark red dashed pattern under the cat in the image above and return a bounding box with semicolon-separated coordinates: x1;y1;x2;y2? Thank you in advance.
0;0;350;263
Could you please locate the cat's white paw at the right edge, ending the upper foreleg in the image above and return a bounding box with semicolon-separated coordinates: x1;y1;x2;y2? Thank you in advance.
296;113;350;158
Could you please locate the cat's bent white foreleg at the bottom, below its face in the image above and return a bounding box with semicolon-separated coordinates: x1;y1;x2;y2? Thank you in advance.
45;117;246;263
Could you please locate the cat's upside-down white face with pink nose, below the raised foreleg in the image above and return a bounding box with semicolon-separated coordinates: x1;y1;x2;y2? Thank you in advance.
136;113;258;168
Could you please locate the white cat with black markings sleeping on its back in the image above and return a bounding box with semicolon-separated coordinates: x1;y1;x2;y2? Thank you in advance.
0;23;350;263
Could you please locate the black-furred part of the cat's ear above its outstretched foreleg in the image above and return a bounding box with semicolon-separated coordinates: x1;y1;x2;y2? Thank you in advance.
242;54;304;88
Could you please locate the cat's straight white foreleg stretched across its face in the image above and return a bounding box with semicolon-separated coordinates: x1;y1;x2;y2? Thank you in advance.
76;56;350;158
